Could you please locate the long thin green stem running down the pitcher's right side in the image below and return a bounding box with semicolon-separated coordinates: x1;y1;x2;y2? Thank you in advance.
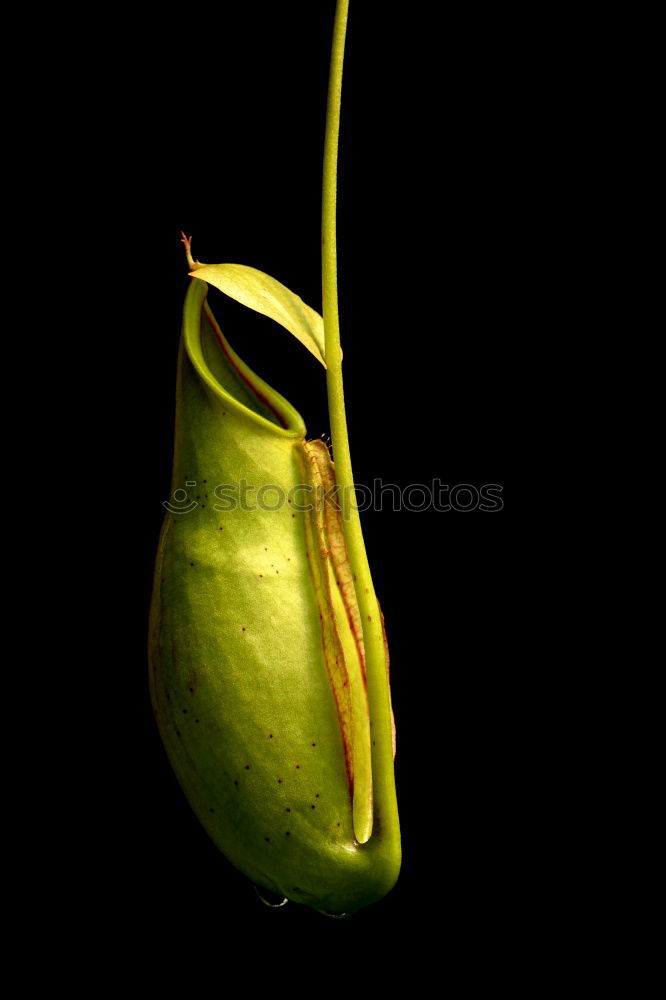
322;0;399;842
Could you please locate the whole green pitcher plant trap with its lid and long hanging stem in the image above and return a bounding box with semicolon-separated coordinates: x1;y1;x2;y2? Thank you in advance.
149;0;400;915
